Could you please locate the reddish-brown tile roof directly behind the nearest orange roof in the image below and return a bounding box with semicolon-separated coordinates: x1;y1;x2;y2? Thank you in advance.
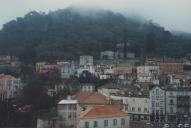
74;92;109;105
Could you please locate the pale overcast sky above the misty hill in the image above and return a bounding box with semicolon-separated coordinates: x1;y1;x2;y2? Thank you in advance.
0;0;191;33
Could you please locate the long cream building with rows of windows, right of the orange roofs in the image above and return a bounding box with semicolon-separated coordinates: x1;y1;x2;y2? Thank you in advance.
98;87;150;122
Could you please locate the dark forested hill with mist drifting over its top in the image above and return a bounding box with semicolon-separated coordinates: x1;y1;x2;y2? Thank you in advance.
0;7;191;63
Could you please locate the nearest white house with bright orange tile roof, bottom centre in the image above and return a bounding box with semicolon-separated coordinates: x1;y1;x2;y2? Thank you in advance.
80;105;129;128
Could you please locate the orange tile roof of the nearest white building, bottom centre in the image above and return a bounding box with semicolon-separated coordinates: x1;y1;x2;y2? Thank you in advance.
80;105;128;119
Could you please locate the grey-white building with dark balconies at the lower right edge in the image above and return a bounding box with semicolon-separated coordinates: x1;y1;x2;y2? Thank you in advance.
166;87;191;122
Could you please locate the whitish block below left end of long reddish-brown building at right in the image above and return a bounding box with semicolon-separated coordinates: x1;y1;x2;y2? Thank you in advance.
137;66;160;84
